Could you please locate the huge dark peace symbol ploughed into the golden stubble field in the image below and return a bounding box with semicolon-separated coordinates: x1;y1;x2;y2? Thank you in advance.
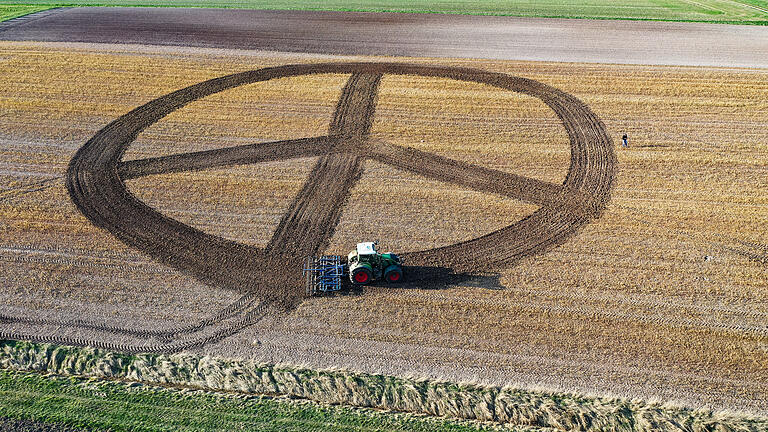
67;63;615;304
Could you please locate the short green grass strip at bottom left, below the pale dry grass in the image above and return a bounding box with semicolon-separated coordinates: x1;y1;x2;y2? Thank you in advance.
0;370;509;432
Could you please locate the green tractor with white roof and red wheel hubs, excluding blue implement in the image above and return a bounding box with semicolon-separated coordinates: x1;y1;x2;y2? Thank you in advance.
347;242;403;285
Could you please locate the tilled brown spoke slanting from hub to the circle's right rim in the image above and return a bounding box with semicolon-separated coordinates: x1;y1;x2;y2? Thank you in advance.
368;140;598;214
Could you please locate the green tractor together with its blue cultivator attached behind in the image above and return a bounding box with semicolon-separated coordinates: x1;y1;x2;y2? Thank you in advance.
303;242;403;296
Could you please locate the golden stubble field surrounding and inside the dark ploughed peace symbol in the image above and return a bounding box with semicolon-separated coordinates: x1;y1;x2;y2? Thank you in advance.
0;43;768;413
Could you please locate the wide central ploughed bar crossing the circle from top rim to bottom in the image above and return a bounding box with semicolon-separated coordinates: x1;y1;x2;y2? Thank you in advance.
266;73;381;257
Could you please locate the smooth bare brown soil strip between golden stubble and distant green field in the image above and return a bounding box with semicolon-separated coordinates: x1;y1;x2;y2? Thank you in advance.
0;7;768;68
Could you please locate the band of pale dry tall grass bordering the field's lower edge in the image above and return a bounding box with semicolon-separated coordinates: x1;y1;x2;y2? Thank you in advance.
0;340;768;432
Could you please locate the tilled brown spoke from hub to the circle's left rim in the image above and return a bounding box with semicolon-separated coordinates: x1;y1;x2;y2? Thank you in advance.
117;136;334;180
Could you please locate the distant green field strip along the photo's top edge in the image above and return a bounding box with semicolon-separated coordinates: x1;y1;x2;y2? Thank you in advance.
0;0;768;25
